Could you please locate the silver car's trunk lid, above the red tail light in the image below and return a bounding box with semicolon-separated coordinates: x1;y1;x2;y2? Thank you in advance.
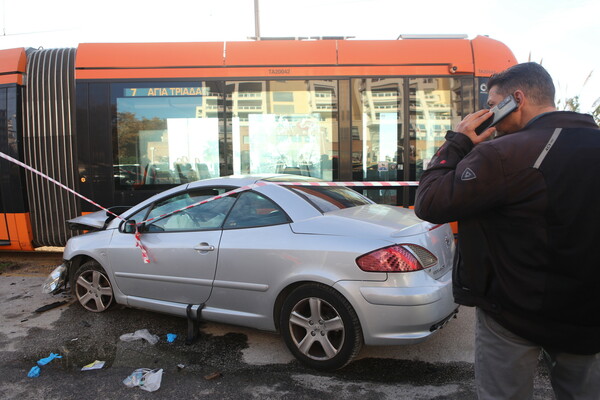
291;204;434;238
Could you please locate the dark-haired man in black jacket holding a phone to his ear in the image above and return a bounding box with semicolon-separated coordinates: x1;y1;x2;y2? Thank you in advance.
415;63;600;400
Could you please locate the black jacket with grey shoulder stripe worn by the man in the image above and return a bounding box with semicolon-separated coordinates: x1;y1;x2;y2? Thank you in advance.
415;112;600;354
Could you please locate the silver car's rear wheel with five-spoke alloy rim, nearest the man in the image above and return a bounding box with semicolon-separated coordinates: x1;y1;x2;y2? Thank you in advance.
279;284;363;371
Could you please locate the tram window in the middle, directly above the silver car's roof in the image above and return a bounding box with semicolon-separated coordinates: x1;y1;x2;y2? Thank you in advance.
225;80;338;180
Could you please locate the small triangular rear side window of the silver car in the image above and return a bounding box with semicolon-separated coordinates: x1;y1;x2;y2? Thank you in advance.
223;192;289;229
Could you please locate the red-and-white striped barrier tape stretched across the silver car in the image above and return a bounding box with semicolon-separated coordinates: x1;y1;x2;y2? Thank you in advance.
0;152;419;264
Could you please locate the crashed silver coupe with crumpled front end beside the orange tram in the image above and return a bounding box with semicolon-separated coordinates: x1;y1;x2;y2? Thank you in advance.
46;175;457;370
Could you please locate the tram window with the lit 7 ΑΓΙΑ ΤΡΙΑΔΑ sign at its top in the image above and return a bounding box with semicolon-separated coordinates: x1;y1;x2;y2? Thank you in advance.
111;82;224;189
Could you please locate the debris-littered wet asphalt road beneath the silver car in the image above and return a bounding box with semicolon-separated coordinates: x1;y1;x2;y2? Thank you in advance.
0;258;554;400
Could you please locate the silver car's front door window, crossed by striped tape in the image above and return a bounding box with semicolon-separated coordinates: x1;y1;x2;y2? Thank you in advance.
147;188;235;232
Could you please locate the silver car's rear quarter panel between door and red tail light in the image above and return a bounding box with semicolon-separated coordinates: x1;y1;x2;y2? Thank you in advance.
203;224;387;330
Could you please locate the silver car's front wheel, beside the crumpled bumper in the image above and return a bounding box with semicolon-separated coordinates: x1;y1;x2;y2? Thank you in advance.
73;260;114;312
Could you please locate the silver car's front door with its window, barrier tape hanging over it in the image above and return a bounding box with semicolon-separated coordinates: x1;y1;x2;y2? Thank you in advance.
108;188;235;304
